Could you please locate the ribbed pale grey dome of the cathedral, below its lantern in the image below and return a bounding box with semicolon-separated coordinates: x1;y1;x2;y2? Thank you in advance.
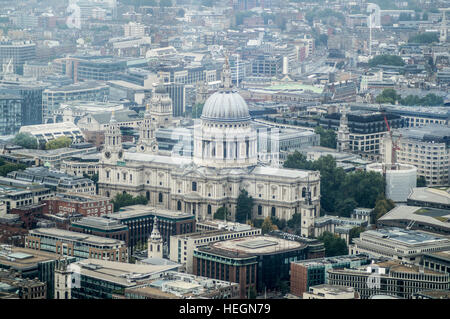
201;90;251;122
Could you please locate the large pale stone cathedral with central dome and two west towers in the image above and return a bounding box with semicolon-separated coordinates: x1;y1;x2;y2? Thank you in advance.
99;63;320;236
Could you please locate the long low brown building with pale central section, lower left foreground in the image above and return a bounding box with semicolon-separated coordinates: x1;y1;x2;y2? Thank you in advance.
25;228;128;262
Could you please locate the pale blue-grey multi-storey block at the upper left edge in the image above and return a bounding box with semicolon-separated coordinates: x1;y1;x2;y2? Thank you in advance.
0;39;36;75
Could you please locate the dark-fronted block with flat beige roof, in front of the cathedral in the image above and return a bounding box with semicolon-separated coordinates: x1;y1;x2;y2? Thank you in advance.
193;236;322;298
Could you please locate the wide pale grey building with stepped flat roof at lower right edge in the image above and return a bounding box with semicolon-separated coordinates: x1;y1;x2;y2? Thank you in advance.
349;227;450;264
